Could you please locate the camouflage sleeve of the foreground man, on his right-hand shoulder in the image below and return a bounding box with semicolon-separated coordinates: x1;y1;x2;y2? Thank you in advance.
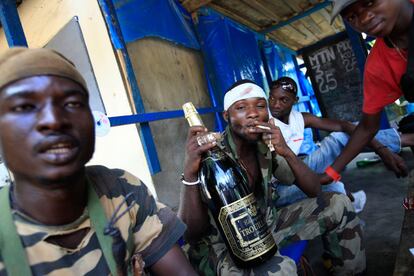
87;166;186;267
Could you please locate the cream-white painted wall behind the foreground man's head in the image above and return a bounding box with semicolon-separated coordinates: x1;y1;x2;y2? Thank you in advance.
0;0;155;194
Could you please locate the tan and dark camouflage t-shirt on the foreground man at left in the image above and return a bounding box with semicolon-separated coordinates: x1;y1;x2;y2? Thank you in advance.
0;166;186;276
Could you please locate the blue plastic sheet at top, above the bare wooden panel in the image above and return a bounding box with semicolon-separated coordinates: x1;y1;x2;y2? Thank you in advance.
113;0;200;49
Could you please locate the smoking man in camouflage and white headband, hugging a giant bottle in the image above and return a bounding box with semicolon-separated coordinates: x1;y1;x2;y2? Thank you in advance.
180;81;365;275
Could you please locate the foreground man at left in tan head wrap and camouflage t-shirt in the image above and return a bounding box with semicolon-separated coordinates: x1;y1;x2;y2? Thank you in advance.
0;48;196;276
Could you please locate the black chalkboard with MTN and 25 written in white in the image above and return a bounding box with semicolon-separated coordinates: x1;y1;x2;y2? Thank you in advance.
303;35;363;122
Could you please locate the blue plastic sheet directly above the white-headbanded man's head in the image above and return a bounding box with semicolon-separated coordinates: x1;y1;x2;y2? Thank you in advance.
196;9;268;106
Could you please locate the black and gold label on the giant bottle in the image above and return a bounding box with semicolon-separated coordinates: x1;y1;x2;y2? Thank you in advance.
218;193;276;261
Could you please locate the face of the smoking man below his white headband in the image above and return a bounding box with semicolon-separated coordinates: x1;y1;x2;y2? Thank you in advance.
224;98;269;142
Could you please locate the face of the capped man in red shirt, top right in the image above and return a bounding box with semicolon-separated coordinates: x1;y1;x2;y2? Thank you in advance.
341;0;402;37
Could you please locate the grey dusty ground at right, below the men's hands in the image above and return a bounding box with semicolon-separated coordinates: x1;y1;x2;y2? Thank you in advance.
305;149;414;276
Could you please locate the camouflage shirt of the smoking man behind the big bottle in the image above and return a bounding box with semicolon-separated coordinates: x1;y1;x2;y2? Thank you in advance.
186;127;295;275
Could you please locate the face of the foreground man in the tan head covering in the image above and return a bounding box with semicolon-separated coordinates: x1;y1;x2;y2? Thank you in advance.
0;76;95;183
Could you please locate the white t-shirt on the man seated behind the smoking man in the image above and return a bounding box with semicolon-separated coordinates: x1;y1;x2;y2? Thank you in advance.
274;109;305;155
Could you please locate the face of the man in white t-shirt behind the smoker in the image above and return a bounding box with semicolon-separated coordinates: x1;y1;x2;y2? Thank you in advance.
269;87;297;120
